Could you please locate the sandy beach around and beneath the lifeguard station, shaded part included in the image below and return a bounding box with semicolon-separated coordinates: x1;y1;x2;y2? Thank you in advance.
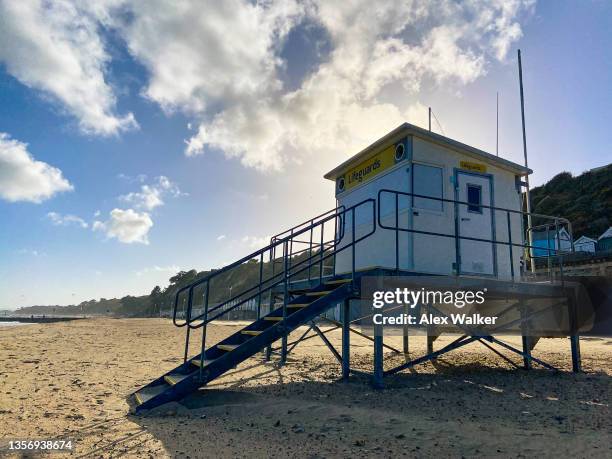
0;319;612;458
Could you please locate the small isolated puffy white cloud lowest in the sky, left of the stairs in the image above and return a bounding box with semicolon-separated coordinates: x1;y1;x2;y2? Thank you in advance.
92;209;153;244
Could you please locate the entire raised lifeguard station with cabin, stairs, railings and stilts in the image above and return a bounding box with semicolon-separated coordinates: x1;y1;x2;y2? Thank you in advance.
130;123;608;411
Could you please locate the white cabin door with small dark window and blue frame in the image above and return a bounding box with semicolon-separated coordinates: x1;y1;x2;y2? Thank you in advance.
456;171;495;275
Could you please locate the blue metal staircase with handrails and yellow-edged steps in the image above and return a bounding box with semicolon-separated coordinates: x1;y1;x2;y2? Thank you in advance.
129;199;376;412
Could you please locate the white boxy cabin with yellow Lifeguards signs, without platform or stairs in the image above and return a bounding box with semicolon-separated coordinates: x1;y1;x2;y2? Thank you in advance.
325;123;531;279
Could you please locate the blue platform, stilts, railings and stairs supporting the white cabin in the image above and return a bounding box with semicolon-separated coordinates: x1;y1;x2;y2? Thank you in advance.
129;193;612;412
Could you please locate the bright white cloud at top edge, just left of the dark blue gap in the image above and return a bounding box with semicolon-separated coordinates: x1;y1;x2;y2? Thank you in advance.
122;0;302;113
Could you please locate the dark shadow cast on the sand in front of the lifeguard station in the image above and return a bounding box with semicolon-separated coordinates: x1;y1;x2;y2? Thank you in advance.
118;359;612;457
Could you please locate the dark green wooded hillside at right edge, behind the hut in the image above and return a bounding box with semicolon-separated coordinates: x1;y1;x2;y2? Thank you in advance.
531;164;612;239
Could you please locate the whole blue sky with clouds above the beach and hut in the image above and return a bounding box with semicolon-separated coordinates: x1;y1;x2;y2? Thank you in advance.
0;0;612;309
